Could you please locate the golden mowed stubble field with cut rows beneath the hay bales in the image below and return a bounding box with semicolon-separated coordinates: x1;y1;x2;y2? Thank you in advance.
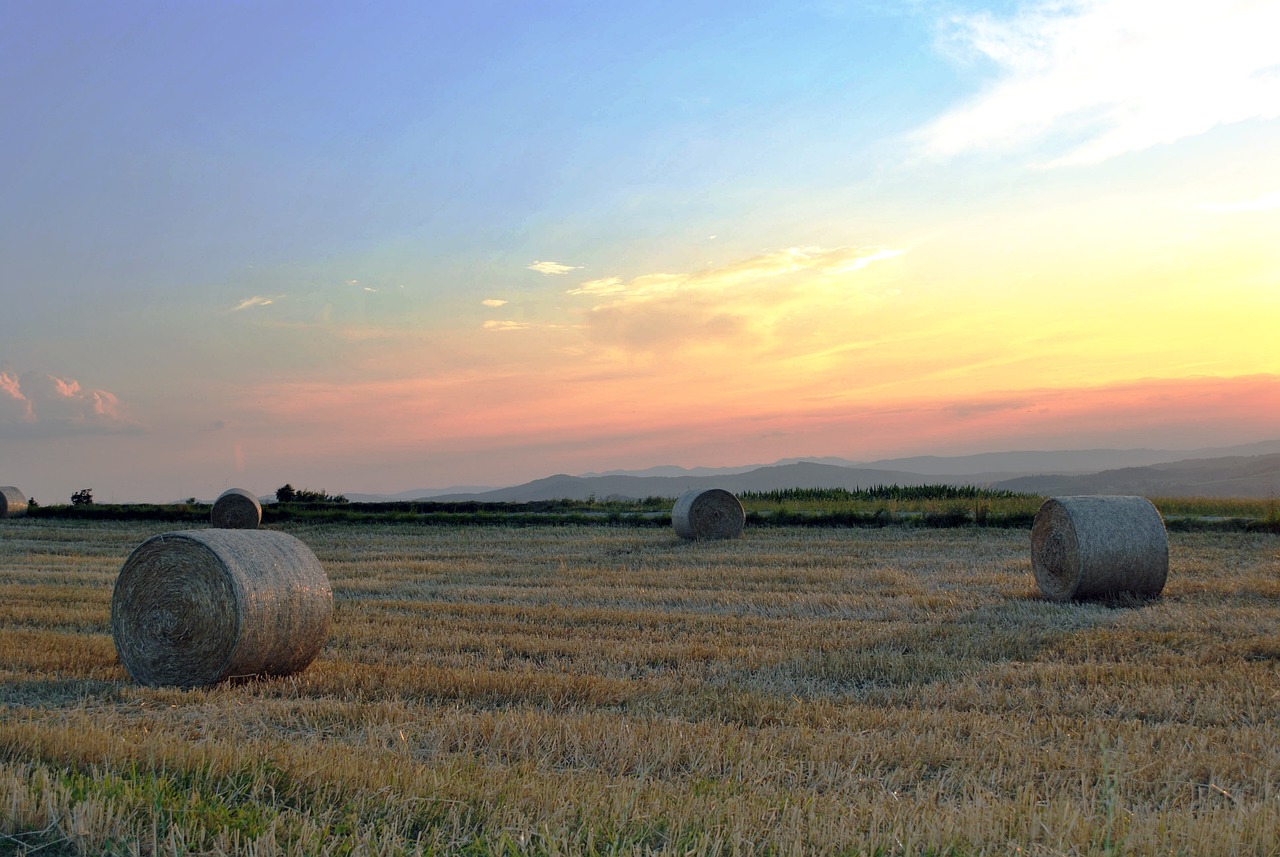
0;519;1280;854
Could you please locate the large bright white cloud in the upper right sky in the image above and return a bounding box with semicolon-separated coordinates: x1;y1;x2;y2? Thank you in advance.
919;0;1280;166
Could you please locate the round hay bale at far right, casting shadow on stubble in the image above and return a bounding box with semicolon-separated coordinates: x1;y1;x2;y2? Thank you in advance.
1032;496;1169;601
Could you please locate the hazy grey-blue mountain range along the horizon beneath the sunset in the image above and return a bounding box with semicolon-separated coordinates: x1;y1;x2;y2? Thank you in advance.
347;440;1280;503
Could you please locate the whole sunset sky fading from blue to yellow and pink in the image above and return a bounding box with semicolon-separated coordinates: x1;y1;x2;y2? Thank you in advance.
0;0;1280;503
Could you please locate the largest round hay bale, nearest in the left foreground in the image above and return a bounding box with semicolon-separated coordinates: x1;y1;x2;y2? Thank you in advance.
111;530;333;687
